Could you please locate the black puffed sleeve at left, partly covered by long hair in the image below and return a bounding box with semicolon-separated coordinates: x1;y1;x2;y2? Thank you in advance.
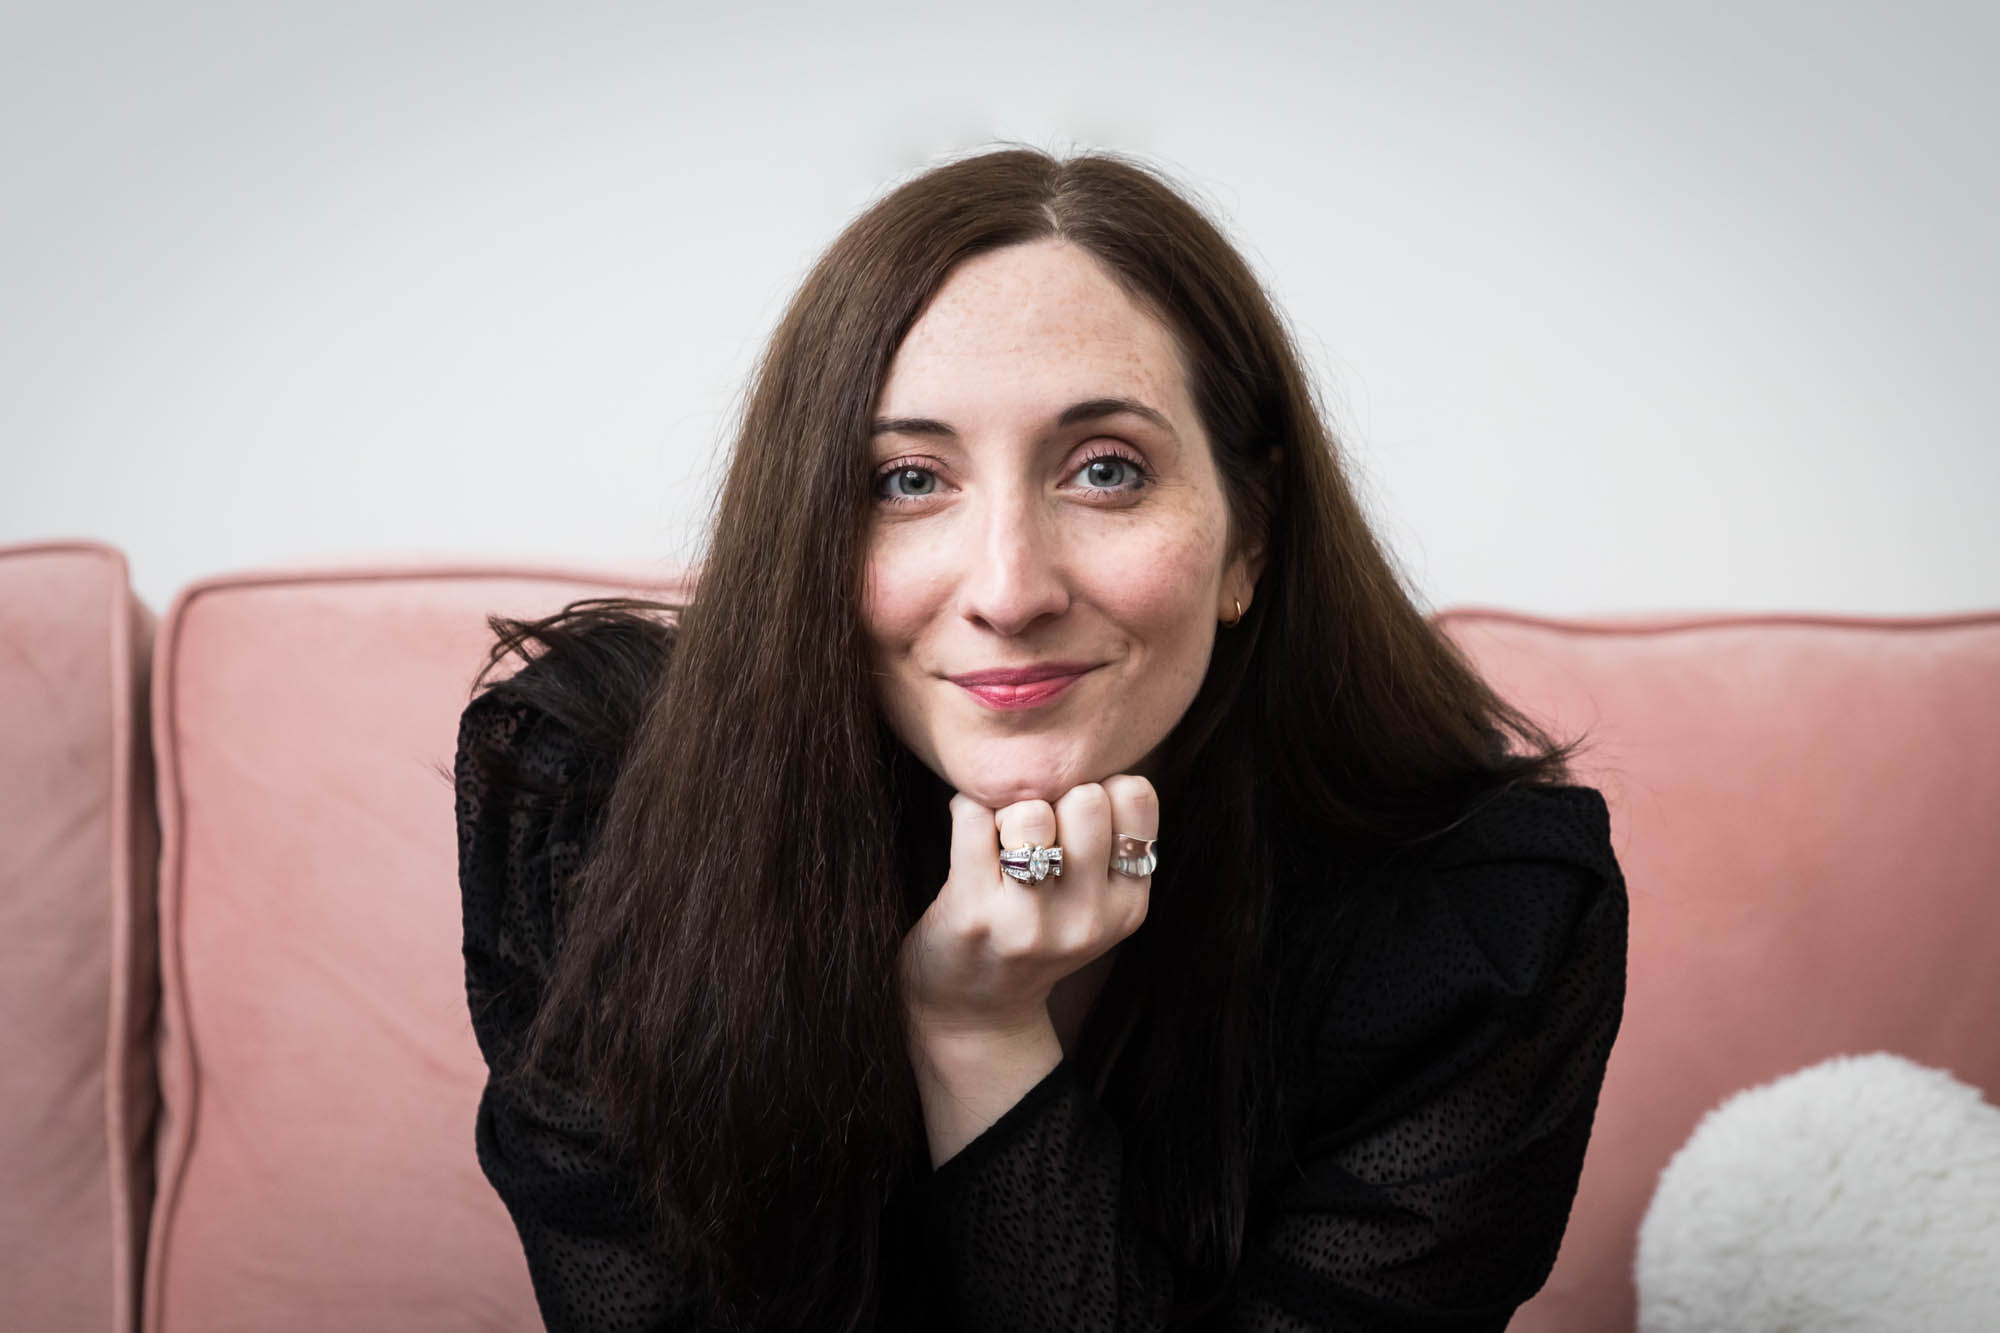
456;669;694;1333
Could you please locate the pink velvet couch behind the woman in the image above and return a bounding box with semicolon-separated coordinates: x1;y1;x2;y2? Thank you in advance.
11;542;2000;1333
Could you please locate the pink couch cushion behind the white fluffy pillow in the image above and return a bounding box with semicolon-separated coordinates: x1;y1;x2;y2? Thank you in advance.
1440;610;2000;1333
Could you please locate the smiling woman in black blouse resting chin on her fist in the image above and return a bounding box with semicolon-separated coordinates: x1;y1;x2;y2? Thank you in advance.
458;150;1624;1329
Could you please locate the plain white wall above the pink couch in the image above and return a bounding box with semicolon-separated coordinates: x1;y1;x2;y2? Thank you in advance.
0;0;2000;612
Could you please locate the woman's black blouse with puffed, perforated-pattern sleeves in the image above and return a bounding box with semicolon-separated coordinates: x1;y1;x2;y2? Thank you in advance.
456;644;1626;1333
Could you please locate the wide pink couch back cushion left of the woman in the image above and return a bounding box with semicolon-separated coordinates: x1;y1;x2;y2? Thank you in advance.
144;566;676;1333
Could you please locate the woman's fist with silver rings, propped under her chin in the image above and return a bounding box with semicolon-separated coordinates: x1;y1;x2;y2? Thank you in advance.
902;775;1160;1047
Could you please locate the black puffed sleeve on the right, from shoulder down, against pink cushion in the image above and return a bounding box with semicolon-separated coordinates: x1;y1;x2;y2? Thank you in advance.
1234;787;1626;1333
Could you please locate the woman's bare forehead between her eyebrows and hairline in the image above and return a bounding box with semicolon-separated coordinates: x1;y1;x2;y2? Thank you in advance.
880;240;1192;422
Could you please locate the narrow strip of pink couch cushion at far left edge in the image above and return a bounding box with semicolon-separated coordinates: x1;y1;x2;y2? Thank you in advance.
0;542;154;1333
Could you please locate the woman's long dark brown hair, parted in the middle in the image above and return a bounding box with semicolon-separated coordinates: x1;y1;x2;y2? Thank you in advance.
472;150;1568;1329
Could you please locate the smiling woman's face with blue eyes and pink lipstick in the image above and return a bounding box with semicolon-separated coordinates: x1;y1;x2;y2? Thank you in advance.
862;240;1256;807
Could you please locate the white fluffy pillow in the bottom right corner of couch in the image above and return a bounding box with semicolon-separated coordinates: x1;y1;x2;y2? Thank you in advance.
1636;1055;2000;1333
